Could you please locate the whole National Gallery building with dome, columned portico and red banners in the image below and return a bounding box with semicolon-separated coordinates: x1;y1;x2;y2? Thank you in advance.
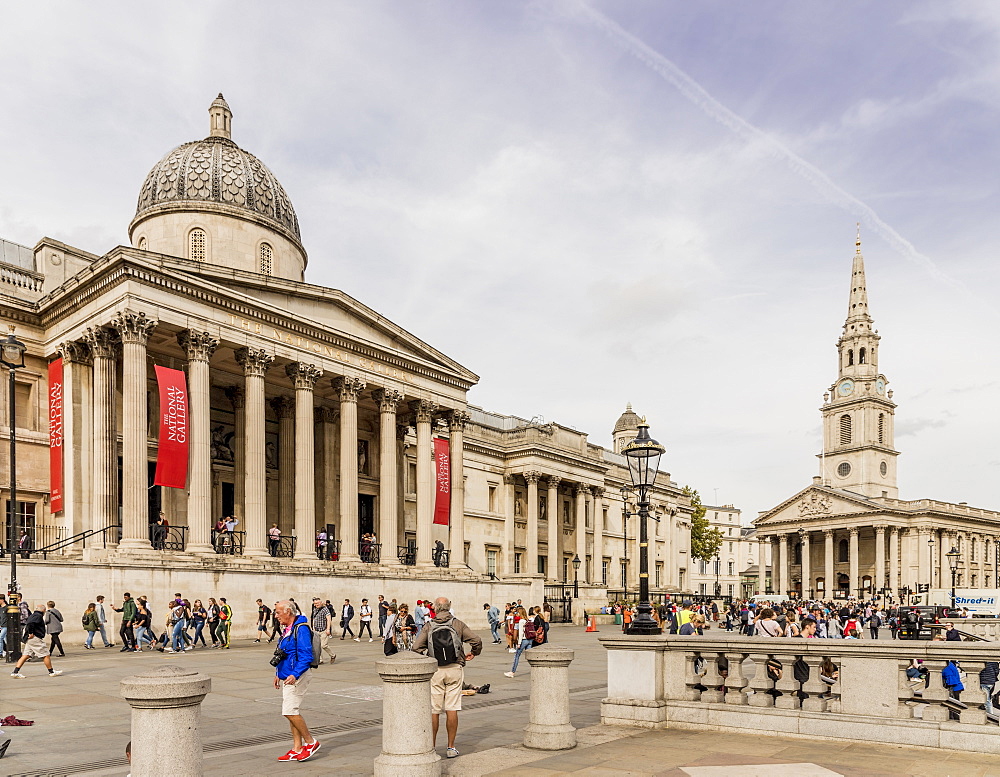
0;95;691;620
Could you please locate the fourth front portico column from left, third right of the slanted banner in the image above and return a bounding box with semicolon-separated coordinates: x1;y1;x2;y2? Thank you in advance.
285;362;323;559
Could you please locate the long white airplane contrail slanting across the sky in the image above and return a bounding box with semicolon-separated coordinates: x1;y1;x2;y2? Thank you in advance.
575;2;964;288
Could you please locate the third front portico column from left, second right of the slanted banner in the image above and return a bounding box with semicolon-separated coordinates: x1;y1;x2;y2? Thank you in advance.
236;348;274;556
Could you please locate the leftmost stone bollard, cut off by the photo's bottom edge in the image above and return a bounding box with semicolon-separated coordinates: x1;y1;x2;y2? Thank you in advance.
121;666;212;777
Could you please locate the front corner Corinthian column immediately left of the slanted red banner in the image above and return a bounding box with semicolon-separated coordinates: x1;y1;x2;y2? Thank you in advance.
111;311;156;550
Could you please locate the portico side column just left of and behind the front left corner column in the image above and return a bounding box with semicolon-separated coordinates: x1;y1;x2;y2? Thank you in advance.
84;328;118;547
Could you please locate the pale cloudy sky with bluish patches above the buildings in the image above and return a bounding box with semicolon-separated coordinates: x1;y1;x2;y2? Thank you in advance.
0;0;1000;520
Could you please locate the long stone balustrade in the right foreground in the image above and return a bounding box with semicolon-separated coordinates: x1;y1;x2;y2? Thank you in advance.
600;635;1000;753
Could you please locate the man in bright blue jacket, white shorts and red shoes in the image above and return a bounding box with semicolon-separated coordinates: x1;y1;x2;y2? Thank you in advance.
271;601;320;761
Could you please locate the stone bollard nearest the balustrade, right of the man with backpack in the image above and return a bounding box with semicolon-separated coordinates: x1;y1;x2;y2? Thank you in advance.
524;645;576;750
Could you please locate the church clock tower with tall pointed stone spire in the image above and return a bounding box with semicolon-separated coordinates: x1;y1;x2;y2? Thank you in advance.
820;229;899;497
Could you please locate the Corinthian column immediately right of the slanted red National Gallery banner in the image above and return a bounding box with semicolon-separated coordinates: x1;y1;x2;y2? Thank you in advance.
177;329;219;553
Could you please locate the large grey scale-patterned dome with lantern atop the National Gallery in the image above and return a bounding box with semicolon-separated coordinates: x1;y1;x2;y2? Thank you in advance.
133;93;302;245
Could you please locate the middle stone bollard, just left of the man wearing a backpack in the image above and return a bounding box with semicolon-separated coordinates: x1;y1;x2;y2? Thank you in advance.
375;651;445;777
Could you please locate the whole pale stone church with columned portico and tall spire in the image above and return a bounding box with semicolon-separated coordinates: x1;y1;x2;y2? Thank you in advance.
754;233;1000;599
